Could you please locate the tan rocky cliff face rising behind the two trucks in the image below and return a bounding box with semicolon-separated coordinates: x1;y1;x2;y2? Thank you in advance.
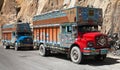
0;0;120;37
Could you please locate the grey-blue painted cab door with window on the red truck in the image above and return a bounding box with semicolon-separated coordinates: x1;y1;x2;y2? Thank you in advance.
60;24;75;48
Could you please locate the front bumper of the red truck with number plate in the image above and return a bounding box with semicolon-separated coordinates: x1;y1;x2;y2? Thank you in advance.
83;48;109;55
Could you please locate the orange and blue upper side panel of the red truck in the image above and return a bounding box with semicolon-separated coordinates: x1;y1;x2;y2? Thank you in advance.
33;8;76;25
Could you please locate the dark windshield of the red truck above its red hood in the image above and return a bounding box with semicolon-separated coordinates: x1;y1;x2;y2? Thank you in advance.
78;25;98;32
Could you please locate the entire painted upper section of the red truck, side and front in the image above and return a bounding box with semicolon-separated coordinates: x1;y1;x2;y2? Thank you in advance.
33;7;103;26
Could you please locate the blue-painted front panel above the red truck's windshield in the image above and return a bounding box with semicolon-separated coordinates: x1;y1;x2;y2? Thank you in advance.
77;7;102;25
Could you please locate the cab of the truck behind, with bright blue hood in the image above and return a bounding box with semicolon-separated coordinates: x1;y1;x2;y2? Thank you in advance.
12;32;33;51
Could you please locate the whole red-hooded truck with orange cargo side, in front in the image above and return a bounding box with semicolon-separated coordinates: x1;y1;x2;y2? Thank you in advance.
33;6;109;63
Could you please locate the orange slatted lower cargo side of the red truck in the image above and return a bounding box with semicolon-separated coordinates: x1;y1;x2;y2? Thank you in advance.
33;26;60;44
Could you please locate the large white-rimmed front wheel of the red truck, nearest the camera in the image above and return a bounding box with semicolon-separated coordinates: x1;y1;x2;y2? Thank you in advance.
70;46;83;64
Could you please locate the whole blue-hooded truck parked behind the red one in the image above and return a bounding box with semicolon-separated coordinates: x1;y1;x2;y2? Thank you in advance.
2;22;33;51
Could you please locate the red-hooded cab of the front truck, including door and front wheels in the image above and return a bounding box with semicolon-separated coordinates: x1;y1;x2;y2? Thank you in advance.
60;23;109;63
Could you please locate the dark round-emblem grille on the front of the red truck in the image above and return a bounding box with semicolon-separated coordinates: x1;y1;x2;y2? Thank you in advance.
96;35;108;47
